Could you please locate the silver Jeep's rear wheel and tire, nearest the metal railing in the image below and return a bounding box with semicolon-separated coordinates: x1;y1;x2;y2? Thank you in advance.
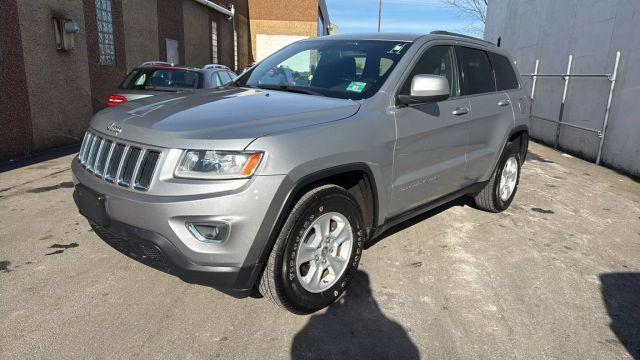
473;142;522;213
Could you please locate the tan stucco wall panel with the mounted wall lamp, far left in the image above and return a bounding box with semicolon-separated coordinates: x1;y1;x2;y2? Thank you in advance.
18;0;92;151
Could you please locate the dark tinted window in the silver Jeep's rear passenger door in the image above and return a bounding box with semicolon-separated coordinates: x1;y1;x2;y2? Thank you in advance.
458;47;496;95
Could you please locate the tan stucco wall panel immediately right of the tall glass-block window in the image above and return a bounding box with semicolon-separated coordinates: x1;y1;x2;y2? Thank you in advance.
122;0;160;72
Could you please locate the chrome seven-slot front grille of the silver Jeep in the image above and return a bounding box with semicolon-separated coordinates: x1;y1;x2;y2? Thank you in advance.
78;131;160;191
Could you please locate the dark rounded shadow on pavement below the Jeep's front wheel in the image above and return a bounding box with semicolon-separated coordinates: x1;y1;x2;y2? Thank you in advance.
291;271;420;359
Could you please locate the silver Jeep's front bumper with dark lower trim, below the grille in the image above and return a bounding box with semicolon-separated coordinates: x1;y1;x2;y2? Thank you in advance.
72;159;284;297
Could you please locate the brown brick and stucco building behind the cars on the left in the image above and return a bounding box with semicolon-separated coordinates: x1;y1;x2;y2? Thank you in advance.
0;0;258;161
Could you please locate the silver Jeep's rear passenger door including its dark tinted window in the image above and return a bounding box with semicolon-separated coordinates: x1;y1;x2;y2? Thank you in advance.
456;46;514;184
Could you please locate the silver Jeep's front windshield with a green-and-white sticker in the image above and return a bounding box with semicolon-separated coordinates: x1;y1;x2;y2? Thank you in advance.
236;40;410;100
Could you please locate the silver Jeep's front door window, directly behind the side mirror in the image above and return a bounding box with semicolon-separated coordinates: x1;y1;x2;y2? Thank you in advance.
400;45;460;97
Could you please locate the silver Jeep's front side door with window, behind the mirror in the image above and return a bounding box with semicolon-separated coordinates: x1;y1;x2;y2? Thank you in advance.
389;45;471;216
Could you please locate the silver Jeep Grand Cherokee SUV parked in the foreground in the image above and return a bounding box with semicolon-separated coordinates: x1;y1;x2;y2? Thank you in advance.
72;32;529;313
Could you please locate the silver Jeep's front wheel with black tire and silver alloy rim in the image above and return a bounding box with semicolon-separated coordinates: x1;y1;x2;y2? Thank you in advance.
258;185;365;314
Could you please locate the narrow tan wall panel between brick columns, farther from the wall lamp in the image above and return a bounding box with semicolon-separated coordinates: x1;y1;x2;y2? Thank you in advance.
182;0;211;67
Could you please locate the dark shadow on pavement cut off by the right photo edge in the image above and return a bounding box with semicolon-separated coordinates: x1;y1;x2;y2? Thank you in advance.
600;272;640;360
